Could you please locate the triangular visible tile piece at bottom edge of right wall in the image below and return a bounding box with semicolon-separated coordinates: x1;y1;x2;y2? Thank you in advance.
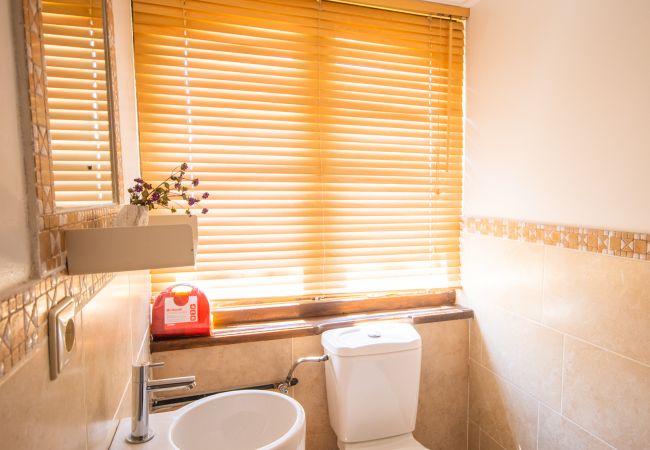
538;405;611;450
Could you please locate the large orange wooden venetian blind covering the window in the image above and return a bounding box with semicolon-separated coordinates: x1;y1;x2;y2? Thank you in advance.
134;0;464;301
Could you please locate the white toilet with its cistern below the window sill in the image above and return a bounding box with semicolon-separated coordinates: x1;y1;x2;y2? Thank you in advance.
322;322;426;450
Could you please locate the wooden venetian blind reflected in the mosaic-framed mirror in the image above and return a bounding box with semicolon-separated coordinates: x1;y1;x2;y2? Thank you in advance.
42;0;113;207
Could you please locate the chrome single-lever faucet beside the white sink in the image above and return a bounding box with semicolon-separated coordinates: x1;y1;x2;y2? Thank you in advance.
126;362;196;444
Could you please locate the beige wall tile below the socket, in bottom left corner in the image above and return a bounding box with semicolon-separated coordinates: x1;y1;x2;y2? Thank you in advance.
0;338;86;450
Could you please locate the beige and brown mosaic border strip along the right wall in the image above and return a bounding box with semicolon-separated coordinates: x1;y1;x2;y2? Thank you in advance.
463;217;650;260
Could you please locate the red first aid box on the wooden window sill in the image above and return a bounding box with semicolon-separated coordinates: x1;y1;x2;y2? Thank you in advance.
151;284;211;338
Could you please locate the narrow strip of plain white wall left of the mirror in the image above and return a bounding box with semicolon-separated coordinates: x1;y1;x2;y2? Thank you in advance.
0;0;31;291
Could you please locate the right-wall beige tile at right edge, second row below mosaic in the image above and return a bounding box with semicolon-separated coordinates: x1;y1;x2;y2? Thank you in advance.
562;338;650;450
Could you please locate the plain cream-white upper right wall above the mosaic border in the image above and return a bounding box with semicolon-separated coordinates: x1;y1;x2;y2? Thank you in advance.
465;0;650;232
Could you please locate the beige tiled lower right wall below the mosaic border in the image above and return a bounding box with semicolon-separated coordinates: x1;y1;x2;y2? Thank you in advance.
462;229;650;450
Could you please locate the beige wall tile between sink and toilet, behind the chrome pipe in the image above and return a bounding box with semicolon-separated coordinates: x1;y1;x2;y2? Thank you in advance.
292;336;336;450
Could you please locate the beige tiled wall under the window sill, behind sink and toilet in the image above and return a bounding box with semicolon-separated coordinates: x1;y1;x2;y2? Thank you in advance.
153;320;469;450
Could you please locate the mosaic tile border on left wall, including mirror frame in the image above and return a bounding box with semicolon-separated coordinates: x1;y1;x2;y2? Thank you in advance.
0;0;123;380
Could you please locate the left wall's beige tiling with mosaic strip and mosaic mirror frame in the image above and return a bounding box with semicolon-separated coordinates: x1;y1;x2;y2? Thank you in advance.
0;0;150;450
